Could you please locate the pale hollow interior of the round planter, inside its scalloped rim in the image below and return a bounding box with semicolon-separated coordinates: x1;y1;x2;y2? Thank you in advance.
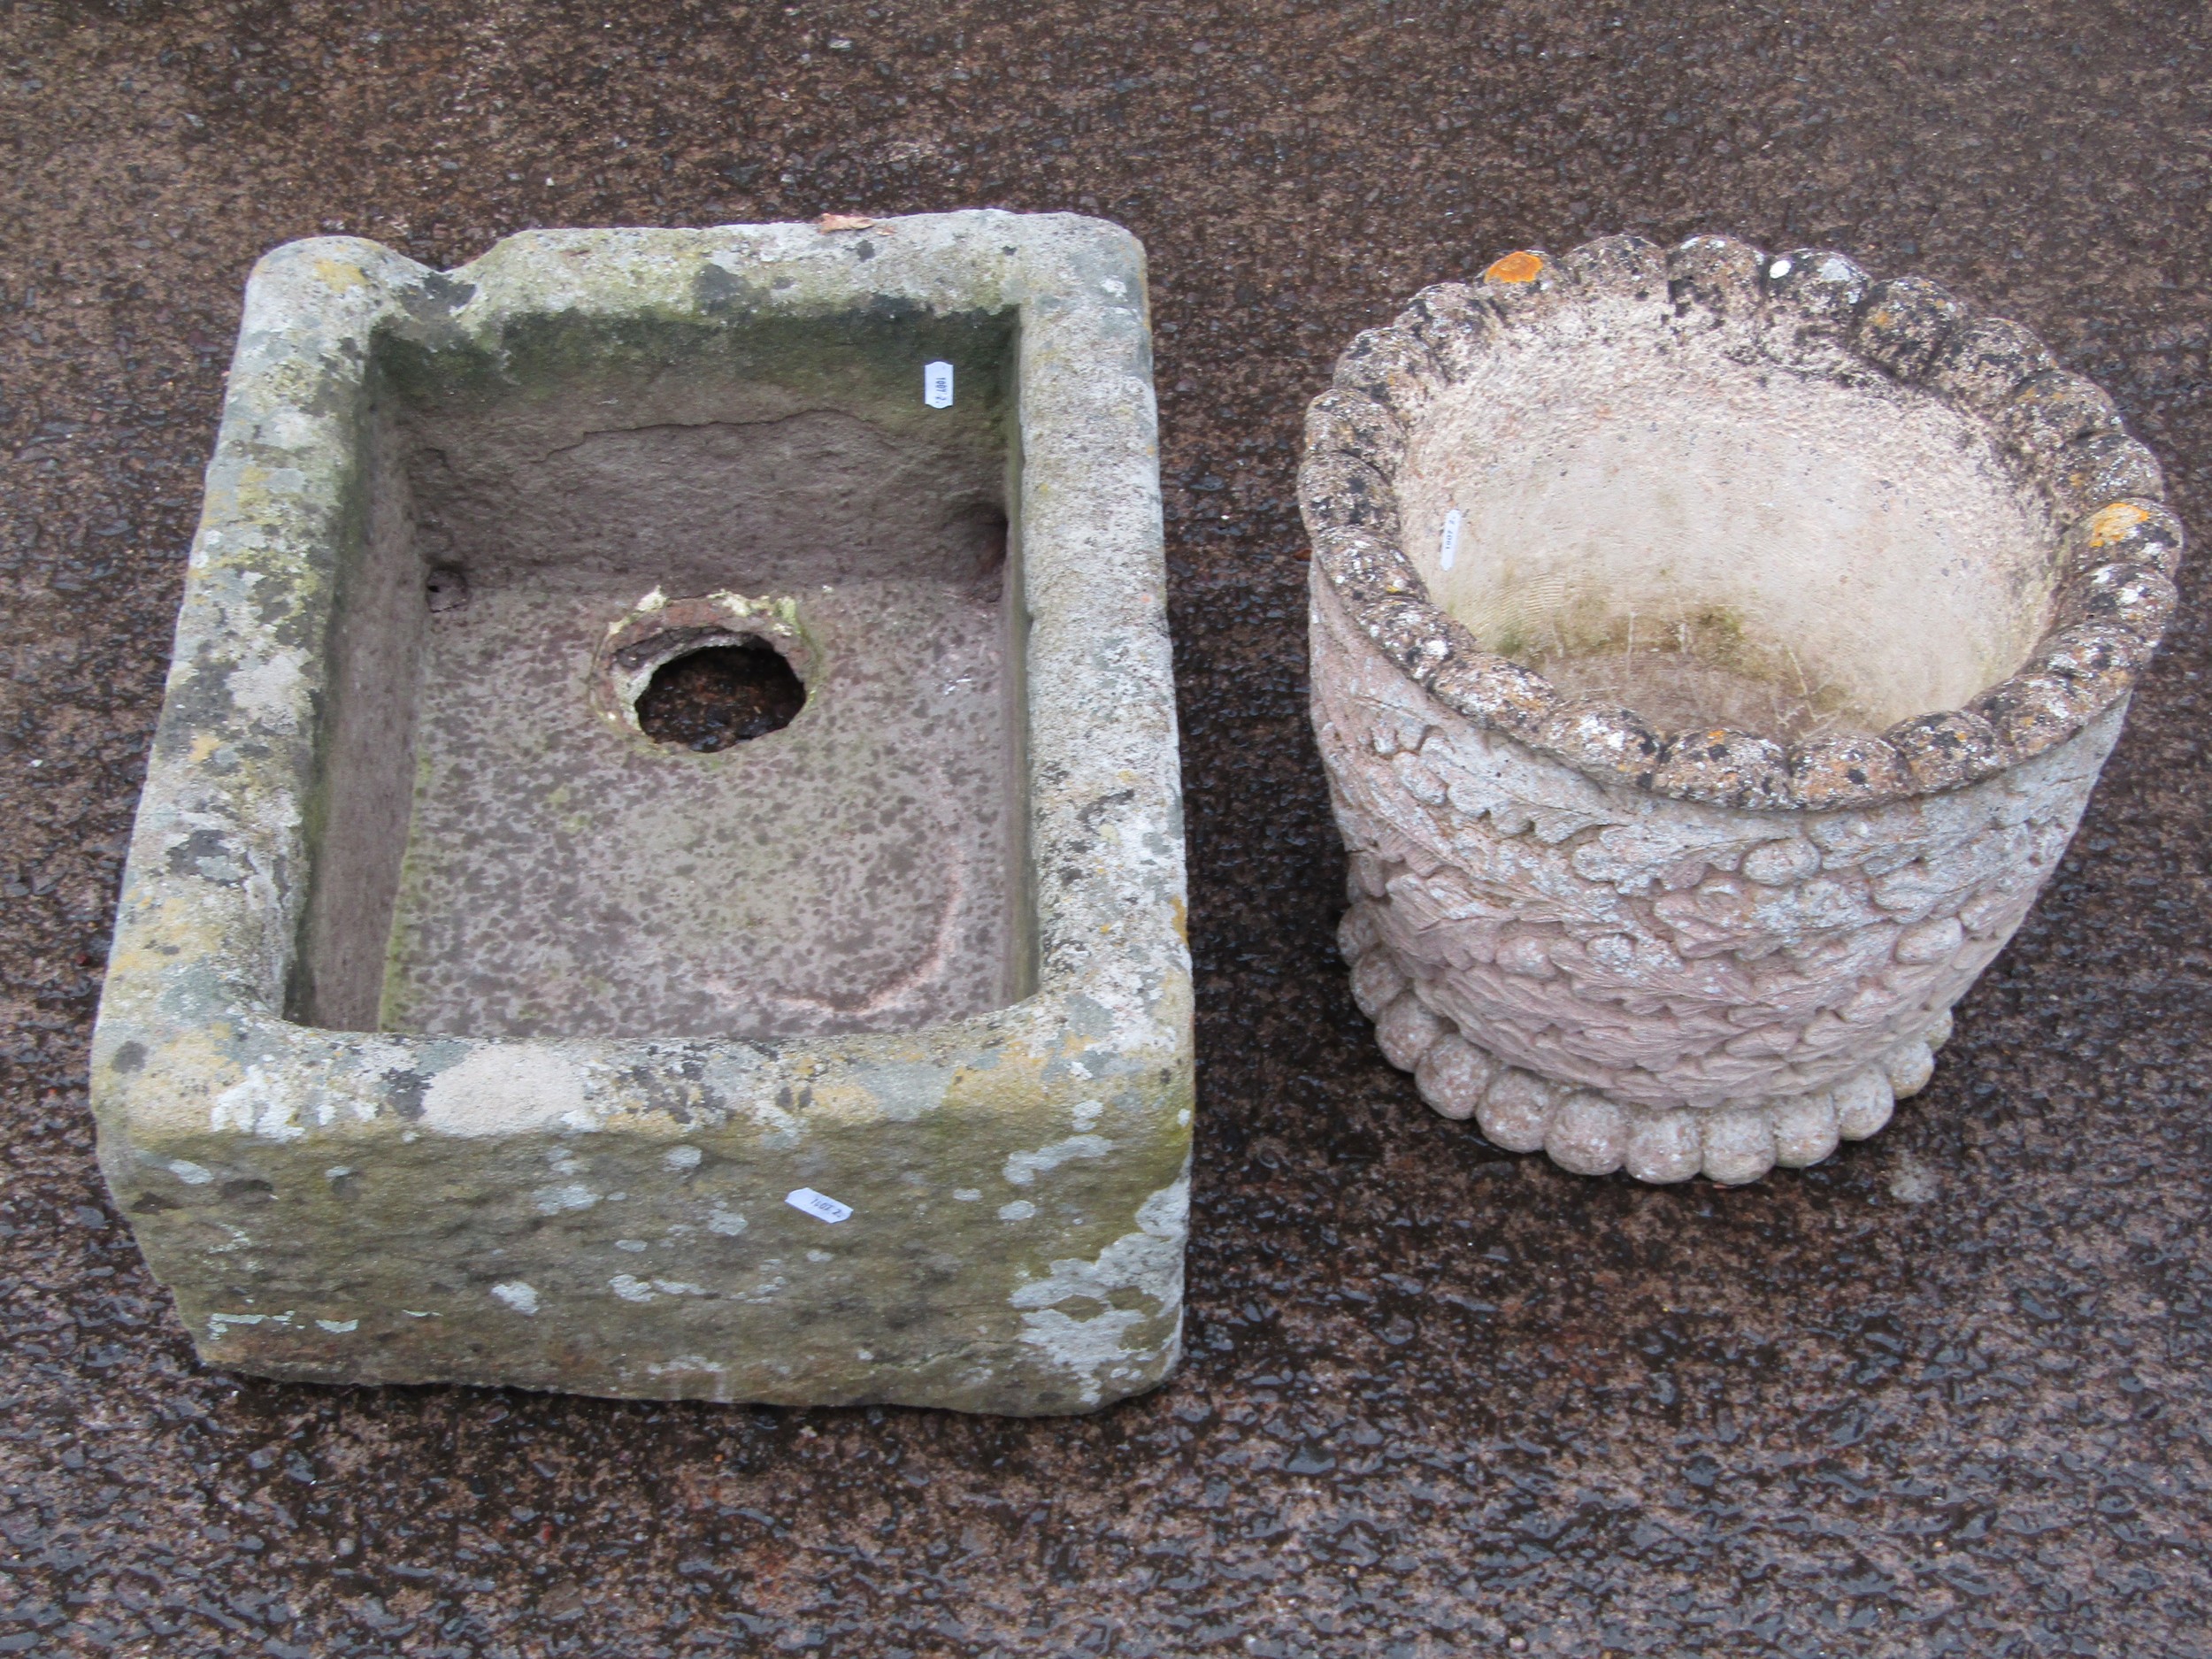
1398;330;2057;741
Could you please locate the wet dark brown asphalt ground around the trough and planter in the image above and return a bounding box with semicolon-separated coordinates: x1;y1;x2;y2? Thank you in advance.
0;0;2212;1659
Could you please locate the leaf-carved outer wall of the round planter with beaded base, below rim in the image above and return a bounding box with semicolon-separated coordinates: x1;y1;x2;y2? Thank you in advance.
1312;578;2124;1181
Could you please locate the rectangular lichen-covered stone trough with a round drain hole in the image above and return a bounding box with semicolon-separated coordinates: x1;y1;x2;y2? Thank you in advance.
93;212;1193;1414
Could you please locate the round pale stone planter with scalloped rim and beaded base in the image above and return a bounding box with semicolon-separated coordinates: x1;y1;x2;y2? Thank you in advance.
1299;237;2181;1181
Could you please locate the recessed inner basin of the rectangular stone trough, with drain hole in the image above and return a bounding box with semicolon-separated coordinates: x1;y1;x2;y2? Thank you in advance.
292;314;1031;1040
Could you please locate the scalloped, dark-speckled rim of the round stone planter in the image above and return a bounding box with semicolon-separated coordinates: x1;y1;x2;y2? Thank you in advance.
1299;237;2184;812
